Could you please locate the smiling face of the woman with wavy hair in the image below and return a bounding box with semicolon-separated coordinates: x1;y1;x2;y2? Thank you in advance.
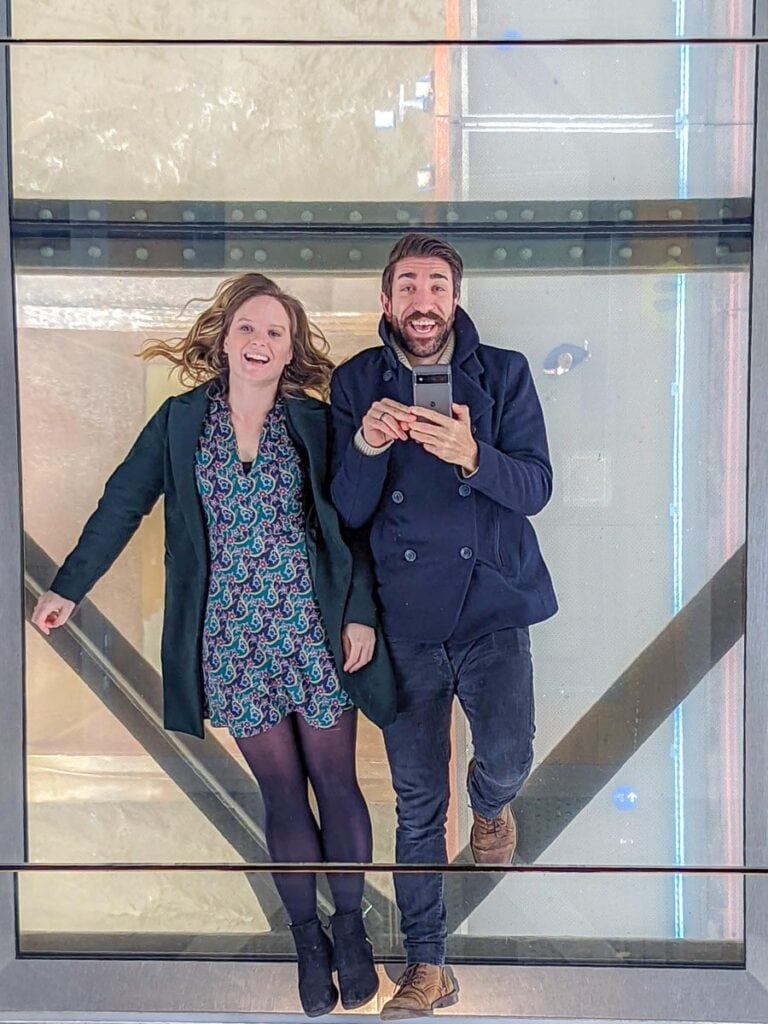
223;295;293;385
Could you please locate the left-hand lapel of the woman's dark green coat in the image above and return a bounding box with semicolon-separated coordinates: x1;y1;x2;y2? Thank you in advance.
168;385;209;565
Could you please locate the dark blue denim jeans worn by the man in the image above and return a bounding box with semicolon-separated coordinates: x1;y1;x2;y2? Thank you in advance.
384;629;534;964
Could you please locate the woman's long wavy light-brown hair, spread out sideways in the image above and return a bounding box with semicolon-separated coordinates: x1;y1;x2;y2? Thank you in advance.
139;273;334;398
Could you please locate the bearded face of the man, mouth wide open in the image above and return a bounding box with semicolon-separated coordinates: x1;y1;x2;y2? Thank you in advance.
381;256;459;360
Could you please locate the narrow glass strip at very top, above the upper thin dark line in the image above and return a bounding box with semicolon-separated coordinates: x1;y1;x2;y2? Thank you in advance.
11;0;753;41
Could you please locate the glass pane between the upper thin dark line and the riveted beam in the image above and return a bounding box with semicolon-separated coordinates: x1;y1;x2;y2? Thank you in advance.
12;45;754;200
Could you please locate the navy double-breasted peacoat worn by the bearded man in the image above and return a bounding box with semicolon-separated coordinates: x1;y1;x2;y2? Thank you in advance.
331;306;557;643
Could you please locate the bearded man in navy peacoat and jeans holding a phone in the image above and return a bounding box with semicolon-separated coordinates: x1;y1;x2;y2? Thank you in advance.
331;233;557;1020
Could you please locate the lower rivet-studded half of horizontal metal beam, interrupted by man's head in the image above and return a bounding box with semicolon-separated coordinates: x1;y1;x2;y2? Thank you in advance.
9;232;752;274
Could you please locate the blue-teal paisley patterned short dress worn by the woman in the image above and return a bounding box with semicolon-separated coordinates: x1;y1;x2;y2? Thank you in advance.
196;395;351;737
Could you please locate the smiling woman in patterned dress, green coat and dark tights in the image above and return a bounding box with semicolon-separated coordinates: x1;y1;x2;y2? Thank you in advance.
32;273;395;1016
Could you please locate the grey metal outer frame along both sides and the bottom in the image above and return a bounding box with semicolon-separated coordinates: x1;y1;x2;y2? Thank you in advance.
0;9;768;1024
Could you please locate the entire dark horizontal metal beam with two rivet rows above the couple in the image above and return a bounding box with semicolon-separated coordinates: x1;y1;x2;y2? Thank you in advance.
11;197;752;274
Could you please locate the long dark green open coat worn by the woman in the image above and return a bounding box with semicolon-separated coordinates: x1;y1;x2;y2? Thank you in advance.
51;384;396;736
